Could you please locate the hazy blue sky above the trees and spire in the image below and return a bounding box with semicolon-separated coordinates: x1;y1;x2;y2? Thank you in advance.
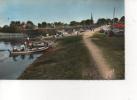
0;0;124;26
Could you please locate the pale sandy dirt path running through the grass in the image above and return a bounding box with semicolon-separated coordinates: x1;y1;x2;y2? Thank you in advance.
83;28;115;79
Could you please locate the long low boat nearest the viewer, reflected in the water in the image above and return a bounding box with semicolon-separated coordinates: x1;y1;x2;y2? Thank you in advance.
10;47;49;55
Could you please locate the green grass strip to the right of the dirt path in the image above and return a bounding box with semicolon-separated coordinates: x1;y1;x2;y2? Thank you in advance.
92;33;125;79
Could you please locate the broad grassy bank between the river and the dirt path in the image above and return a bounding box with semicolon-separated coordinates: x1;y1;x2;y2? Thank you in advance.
19;36;100;79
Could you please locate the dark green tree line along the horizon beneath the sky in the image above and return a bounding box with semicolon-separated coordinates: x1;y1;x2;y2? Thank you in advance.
0;16;125;33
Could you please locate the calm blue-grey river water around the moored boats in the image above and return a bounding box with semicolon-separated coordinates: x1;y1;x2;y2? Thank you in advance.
0;41;40;79
